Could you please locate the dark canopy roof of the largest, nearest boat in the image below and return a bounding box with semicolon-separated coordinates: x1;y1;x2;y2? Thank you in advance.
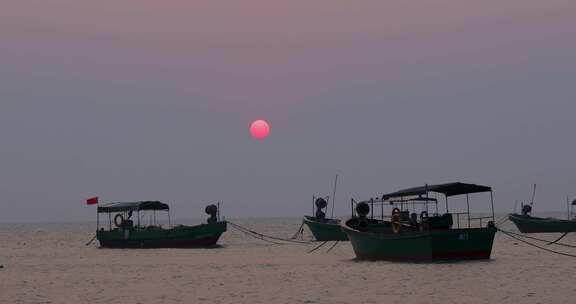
382;183;492;201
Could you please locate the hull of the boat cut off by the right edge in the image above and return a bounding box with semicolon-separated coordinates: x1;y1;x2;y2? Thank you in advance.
508;214;576;233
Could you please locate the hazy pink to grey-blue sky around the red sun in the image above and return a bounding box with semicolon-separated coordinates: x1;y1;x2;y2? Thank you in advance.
0;0;576;222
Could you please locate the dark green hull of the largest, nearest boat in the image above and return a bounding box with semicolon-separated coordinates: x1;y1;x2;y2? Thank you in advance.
342;225;496;261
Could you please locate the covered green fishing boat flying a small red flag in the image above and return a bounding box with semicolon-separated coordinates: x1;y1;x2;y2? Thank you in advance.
96;201;227;248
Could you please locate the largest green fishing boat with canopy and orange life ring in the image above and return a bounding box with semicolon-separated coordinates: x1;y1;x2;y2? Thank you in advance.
342;183;496;261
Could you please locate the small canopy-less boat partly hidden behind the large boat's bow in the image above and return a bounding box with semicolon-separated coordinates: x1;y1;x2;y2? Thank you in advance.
303;197;348;242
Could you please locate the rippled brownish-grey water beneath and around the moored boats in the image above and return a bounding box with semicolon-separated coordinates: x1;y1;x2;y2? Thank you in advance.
0;218;576;304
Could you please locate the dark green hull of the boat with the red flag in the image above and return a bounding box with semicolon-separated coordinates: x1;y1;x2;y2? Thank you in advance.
96;222;227;248
